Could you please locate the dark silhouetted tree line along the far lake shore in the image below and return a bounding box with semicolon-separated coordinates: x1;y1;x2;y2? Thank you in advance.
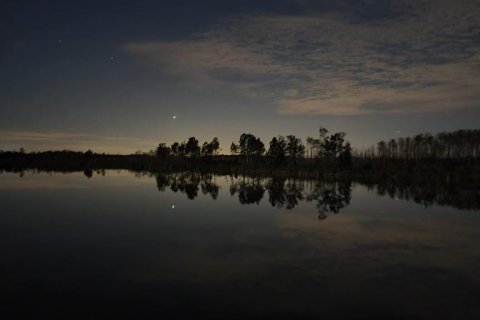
0;127;480;181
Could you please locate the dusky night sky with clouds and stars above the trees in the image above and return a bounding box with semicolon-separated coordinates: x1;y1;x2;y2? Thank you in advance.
0;0;480;153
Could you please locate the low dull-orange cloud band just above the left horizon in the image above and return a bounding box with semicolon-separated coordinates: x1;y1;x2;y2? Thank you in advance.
0;131;156;153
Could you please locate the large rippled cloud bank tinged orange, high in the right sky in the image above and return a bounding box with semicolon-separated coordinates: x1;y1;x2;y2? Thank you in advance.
126;0;480;115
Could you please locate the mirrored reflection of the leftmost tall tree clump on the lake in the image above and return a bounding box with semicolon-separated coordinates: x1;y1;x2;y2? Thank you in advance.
156;172;219;199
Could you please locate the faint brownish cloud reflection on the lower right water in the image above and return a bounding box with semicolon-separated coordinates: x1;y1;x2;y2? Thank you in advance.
278;209;478;279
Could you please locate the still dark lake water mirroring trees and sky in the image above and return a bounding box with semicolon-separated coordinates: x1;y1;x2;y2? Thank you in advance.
0;172;480;319
